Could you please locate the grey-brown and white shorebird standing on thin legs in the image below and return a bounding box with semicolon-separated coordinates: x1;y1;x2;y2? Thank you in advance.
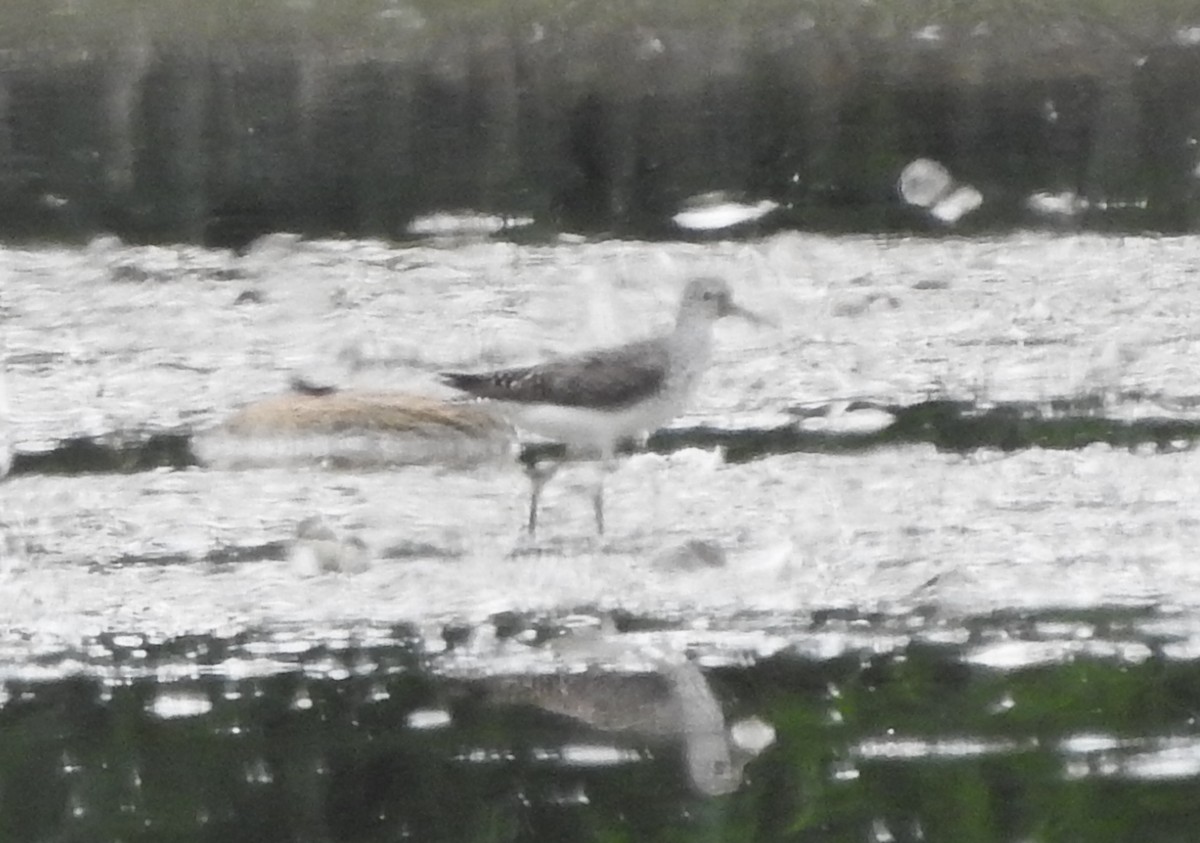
442;277;767;534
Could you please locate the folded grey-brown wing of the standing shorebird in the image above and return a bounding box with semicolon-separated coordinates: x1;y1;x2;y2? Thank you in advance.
442;340;667;409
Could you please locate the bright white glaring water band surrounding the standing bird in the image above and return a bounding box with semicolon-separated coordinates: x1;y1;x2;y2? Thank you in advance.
7;234;1200;710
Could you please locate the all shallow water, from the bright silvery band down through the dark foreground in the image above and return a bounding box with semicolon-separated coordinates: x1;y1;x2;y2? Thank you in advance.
0;235;1200;841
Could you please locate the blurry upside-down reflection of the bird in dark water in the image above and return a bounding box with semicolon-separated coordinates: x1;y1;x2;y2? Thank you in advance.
472;662;774;796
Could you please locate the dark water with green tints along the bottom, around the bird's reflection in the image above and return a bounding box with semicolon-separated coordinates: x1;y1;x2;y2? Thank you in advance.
0;610;1200;843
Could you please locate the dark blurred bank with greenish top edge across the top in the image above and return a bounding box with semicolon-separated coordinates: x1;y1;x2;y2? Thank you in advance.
0;0;1200;245
